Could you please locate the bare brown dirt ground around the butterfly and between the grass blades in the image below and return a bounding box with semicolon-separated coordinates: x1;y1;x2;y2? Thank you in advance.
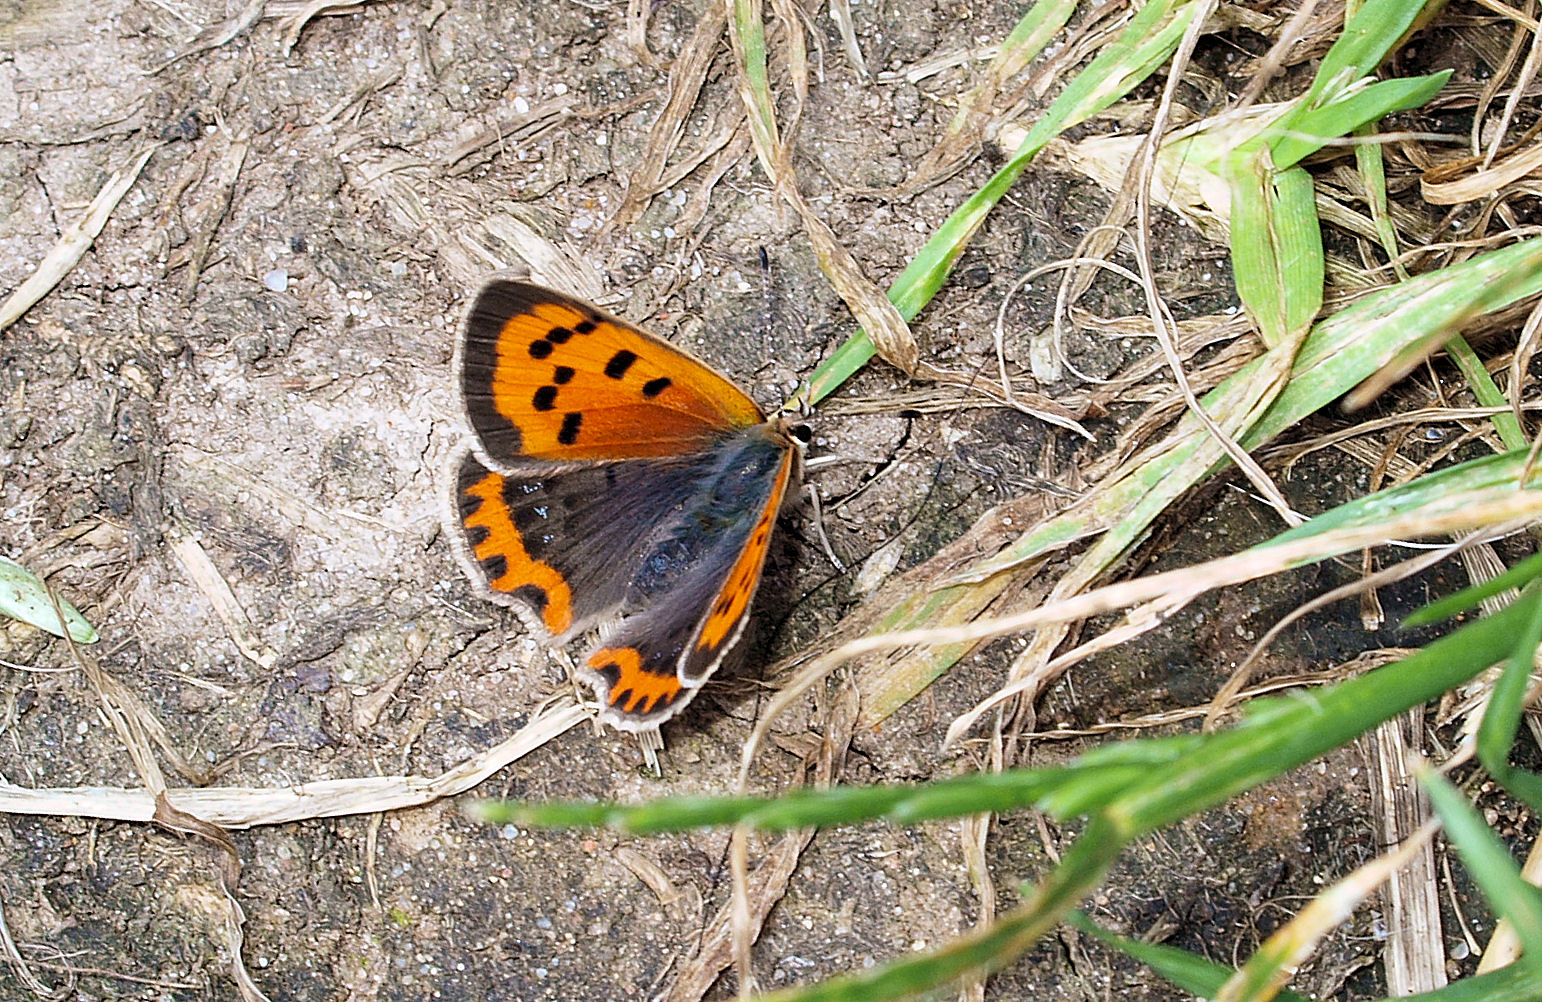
0;0;1492;1000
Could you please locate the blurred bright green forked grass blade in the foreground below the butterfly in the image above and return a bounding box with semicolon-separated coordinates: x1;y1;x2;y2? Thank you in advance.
480;606;1542;1002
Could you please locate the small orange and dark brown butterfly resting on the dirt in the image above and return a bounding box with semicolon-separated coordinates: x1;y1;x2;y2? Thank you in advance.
455;279;808;731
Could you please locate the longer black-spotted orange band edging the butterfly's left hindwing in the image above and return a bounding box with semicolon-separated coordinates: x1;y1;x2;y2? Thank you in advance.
461;470;574;637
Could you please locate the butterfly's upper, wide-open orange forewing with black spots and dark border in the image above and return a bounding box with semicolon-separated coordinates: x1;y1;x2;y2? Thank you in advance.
461;281;765;462
